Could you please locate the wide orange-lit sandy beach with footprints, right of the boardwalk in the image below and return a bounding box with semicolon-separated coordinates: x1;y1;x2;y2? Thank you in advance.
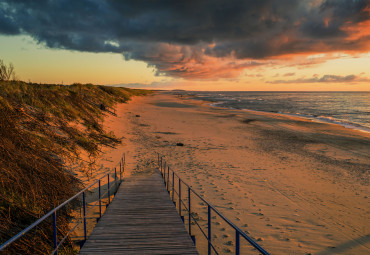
98;93;370;254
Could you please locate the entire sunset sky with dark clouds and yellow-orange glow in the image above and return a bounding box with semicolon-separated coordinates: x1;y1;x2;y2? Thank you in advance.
0;0;370;91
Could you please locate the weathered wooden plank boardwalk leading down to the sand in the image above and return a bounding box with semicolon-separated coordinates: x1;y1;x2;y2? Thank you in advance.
80;171;198;255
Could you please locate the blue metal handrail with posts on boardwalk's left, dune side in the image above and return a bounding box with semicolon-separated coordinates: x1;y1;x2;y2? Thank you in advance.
0;153;126;254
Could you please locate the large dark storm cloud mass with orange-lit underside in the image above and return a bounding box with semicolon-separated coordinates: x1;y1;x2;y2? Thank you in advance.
0;0;370;79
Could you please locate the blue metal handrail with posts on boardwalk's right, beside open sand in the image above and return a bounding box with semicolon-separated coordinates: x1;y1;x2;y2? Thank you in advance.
157;153;269;255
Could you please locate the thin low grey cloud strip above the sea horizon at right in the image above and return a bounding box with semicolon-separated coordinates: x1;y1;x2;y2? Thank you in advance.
268;74;370;84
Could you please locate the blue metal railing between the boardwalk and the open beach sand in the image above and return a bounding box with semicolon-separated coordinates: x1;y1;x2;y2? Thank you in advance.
158;154;269;255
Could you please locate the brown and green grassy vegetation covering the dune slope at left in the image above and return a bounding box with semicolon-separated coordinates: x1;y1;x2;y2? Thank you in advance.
0;81;150;254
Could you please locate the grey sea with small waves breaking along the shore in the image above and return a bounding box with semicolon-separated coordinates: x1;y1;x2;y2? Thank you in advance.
172;91;370;132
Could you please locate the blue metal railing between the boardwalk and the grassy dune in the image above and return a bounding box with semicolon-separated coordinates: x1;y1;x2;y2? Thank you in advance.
0;154;126;254
